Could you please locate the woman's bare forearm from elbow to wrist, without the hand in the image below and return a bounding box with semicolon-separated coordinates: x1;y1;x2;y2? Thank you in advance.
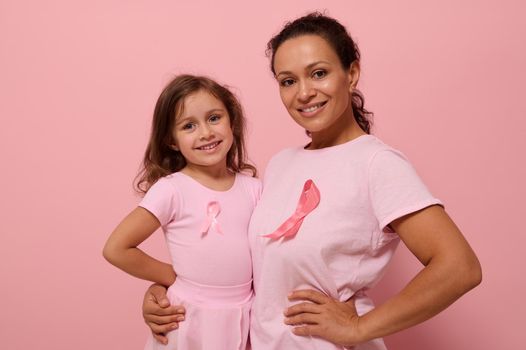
358;254;481;341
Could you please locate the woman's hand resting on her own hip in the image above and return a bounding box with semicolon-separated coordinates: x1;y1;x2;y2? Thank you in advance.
284;290;361;346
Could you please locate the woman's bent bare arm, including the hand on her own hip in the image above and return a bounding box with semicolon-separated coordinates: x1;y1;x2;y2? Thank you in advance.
285;205;482;346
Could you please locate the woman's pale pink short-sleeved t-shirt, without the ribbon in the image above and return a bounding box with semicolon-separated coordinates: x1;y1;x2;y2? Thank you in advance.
249;135;440;350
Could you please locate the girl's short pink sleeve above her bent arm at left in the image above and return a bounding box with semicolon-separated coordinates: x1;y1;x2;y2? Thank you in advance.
139;178;178;226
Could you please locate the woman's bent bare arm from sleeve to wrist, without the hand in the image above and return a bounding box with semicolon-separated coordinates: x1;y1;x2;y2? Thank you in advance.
359;206;482;339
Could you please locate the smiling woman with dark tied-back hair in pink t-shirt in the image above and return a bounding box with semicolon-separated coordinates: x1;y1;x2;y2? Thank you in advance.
143;13;481;350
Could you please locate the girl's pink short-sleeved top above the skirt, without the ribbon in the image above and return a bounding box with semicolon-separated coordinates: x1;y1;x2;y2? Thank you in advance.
139;172;261;286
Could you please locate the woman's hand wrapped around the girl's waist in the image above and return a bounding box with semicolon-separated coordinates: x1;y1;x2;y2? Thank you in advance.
142;284;185;345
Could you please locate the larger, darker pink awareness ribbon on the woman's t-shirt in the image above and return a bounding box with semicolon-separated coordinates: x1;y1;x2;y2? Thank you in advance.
263;179;320;239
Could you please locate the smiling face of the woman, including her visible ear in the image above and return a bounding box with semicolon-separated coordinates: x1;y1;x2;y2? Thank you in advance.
274;35;359;140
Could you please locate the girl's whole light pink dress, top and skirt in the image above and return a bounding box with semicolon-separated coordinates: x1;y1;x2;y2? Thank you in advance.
140;172;261;350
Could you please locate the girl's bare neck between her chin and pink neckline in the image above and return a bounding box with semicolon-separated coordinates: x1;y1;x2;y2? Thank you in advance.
181;164;236;191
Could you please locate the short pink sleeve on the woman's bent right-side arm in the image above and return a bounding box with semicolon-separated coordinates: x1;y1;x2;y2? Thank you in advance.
369;149;442;231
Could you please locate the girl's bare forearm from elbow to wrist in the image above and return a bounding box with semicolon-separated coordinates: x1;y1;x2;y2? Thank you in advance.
106;248;176;286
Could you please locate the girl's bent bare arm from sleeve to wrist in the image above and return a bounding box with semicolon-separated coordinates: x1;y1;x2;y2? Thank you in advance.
103;207;175;286
